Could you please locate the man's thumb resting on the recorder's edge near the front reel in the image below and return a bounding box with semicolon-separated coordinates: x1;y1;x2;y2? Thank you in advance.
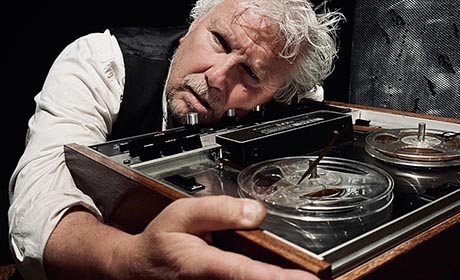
151;195;266;235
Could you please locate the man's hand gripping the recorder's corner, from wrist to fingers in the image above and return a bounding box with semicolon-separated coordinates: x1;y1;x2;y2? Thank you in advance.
115;196;317;280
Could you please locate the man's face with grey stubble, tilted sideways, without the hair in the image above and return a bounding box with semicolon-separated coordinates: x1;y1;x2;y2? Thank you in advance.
166;0;292;125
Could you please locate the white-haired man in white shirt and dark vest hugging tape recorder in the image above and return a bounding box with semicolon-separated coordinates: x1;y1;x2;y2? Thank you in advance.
8;0;341;279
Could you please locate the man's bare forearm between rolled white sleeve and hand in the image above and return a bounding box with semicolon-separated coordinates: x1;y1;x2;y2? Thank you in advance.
43;207;133;279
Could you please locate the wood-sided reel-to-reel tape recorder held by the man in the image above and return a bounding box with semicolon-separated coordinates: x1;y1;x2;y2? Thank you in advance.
65;103;460;279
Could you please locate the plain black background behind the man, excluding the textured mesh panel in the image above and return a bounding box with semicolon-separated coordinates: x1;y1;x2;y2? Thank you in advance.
0;0;353;265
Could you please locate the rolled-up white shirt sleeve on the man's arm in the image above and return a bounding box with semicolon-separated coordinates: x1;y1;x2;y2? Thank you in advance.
8;31;125;279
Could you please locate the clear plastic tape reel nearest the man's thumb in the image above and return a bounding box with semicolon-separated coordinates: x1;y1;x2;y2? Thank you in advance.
237;156;393;215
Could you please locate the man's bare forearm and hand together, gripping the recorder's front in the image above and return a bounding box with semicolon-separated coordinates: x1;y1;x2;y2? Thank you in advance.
44;196;317;280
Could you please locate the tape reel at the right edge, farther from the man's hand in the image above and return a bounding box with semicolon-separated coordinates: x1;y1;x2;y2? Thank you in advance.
366;127;460;167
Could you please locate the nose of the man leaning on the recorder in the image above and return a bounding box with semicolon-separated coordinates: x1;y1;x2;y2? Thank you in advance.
205;55;235;91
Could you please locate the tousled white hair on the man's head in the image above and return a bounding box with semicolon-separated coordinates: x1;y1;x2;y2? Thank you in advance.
190;0;344;103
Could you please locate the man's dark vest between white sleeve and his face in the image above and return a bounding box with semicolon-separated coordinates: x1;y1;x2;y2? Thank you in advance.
108;26;187;140
